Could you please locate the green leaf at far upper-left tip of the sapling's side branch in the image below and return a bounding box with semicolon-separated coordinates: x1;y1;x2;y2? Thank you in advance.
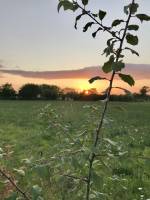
57;0;78;12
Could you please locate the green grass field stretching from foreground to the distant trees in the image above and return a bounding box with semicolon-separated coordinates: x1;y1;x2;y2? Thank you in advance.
0;101;150;200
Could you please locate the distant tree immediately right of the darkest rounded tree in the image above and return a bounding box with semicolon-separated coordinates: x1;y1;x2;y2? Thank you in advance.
40;84;61;100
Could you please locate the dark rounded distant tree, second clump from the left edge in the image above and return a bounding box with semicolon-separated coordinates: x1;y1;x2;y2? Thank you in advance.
18;83;40;100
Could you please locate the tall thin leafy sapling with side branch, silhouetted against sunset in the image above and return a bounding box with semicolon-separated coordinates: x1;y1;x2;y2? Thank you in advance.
58;0;150;200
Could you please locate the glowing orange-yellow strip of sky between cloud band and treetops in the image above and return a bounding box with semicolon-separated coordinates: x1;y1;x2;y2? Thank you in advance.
0;73;150;95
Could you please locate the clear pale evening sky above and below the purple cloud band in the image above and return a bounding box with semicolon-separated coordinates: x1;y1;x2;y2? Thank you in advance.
0;0;150;93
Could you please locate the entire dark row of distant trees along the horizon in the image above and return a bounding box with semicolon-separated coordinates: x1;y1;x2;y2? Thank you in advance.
0;83;150;101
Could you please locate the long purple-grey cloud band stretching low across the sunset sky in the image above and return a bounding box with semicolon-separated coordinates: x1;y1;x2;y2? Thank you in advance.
0;64;150;80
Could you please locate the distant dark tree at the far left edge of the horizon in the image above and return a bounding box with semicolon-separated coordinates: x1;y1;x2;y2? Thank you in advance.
0;83;16;99
